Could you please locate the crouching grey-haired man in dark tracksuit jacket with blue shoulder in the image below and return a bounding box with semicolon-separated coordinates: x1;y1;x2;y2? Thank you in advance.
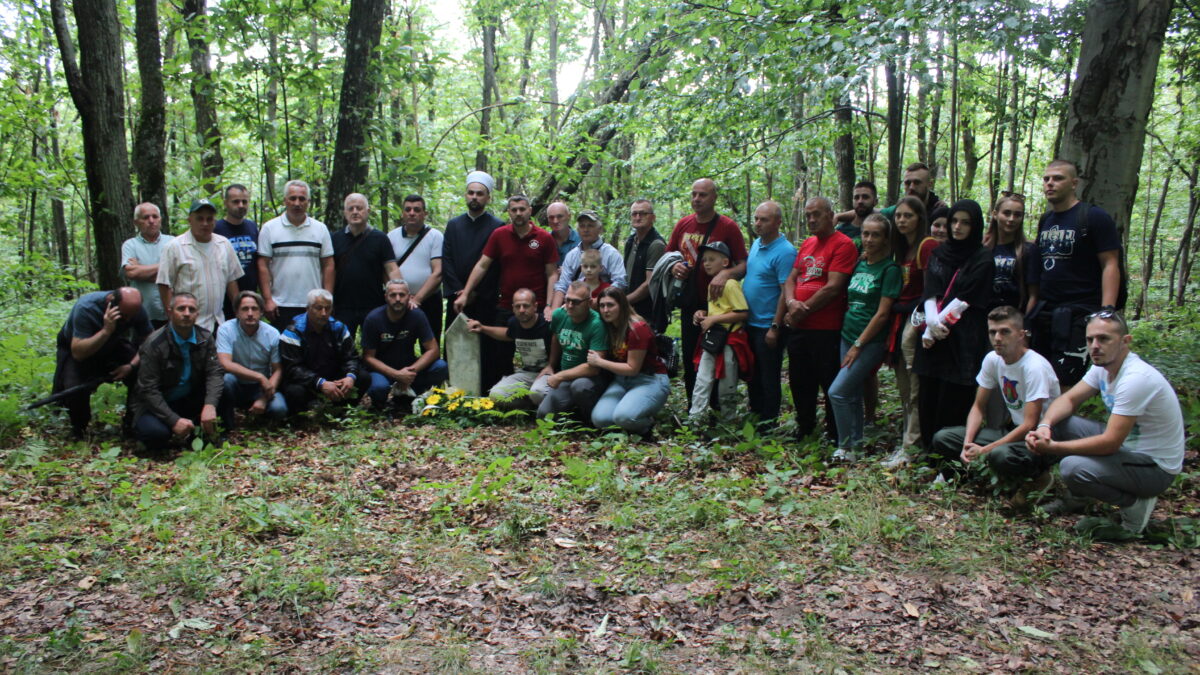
280;288;370;413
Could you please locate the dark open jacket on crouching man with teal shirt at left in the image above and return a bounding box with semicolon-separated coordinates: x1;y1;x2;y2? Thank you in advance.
133;323;224;428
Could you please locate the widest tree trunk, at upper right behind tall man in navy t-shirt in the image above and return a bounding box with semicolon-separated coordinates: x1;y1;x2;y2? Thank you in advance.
1062;0;1172;239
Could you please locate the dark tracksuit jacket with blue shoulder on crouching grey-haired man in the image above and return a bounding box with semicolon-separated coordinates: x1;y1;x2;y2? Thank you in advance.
280;313;362;392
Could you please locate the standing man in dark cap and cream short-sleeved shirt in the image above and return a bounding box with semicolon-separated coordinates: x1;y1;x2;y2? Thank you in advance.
157;199;245;331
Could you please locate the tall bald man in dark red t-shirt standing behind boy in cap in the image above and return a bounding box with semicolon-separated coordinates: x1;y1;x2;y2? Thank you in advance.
667;178;746;407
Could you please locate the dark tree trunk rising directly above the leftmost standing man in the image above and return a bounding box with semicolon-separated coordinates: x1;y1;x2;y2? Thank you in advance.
133;0;170;214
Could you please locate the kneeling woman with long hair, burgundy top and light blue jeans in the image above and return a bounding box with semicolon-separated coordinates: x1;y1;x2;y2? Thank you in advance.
588;286;670;435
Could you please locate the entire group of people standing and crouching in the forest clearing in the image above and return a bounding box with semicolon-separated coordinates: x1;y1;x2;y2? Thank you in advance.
55;161;1183;532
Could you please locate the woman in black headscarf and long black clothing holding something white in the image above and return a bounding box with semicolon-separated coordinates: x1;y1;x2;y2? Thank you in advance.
913;199;995;462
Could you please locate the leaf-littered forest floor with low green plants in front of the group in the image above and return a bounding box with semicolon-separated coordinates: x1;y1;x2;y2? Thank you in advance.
0;403;1200;673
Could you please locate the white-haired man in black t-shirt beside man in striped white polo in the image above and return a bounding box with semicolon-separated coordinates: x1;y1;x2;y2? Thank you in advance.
332;192;400;338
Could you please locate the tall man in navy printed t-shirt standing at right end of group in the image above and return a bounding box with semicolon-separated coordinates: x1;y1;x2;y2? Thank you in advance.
1026;160;1121;389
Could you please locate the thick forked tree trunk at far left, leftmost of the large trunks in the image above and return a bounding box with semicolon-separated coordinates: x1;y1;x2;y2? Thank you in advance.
50;0;133;288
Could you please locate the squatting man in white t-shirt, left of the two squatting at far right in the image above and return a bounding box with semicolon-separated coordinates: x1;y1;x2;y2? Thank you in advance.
934;305;1062;504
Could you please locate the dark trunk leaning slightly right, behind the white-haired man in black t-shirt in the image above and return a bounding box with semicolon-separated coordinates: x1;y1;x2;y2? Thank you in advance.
325;0;388;227
